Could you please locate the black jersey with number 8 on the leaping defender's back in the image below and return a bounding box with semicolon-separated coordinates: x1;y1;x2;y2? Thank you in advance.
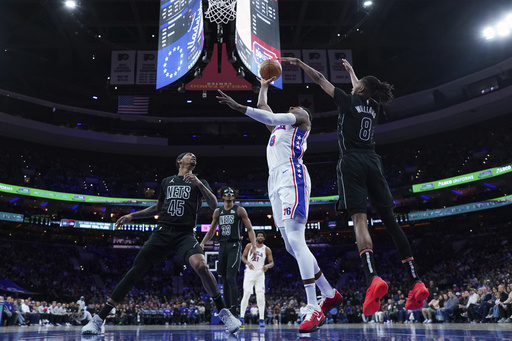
334;88;379;156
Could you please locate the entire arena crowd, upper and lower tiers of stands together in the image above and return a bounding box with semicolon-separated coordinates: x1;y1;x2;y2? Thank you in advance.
0;102;512;325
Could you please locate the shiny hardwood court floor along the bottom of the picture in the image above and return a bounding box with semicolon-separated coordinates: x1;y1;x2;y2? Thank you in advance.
0;323;512;341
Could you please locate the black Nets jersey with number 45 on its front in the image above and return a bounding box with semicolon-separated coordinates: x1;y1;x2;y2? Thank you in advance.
158;175;211;229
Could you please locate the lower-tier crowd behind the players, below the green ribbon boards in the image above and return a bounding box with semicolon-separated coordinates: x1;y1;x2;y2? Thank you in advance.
0;212;512;325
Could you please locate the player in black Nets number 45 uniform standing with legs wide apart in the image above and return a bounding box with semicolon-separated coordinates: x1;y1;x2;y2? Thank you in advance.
82;152;241;334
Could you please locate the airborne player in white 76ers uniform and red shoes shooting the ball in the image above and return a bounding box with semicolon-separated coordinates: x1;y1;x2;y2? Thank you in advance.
217;77;341;333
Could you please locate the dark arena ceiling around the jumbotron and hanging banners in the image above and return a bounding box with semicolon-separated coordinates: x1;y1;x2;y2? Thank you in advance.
0;0;512;116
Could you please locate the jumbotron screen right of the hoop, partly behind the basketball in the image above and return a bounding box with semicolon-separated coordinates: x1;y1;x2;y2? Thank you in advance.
235;0;283;89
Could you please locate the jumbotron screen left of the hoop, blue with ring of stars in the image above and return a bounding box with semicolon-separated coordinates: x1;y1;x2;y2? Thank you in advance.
156;0;204;89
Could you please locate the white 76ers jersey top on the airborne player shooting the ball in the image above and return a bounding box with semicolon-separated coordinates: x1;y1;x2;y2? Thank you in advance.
267;125;309;171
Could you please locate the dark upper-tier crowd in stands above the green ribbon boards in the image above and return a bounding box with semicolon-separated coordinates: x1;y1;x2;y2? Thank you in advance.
0;112;512;208
